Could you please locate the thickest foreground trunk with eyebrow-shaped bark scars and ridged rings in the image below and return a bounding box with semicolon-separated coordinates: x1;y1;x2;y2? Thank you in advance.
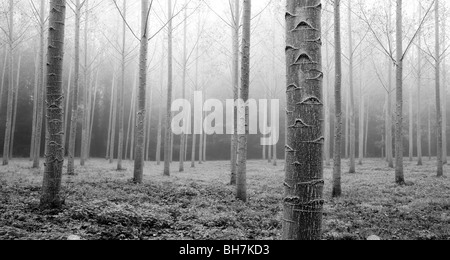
283;0;324;240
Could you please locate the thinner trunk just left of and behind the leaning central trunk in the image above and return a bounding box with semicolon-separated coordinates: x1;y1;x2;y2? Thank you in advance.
230;0;241;185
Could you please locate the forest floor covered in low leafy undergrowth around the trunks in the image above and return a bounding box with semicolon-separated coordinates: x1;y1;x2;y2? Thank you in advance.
0;159;450;240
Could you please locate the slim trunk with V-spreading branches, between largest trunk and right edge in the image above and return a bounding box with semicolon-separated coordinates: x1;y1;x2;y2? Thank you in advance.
395;0;405;185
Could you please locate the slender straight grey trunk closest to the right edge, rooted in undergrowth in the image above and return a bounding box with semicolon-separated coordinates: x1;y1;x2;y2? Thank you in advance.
435;0;444;177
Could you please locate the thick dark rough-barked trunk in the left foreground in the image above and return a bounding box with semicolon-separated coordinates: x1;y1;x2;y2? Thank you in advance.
40;0;66;209
